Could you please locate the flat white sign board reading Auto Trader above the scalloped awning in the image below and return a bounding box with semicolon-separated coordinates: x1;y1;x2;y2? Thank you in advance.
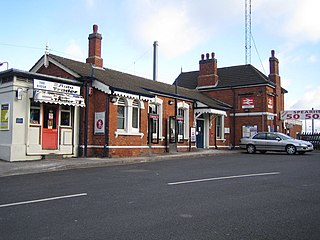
33;79;80;95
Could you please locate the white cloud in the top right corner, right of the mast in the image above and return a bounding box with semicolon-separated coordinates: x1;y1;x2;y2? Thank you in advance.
252;0;320;45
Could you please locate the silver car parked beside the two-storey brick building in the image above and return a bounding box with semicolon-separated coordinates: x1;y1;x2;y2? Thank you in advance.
240;132;313;155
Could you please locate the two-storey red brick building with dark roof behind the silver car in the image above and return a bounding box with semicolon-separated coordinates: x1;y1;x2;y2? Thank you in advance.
175;50;298;146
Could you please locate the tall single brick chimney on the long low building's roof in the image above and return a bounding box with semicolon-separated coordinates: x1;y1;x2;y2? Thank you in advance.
86;24;103;68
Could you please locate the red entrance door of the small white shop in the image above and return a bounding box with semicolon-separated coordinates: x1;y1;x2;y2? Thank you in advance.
42;104;58;149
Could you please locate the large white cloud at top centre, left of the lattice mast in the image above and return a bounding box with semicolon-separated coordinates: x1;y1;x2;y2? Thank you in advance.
127;0;244;58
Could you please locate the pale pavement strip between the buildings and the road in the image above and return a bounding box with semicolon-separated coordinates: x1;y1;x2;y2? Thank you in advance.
0;150;239;177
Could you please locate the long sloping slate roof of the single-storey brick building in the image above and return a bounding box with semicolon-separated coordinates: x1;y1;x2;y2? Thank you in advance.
38;54;231;111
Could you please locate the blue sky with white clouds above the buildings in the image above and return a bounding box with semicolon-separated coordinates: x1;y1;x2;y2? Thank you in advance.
0;0;320;131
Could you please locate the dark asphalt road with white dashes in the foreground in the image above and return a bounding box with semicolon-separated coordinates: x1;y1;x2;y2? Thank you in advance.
0;152;320;240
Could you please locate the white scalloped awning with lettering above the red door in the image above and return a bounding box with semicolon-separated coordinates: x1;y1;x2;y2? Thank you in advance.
34;89;85;107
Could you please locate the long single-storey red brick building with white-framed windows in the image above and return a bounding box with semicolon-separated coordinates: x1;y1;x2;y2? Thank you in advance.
31;25;231;157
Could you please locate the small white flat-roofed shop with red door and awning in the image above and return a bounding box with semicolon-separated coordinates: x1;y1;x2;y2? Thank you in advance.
0;69;85;161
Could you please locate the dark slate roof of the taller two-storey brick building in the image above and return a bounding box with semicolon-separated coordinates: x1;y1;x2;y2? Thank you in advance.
174;64;287;92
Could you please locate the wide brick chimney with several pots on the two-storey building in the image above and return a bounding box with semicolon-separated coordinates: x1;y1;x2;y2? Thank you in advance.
197;53;218;89
